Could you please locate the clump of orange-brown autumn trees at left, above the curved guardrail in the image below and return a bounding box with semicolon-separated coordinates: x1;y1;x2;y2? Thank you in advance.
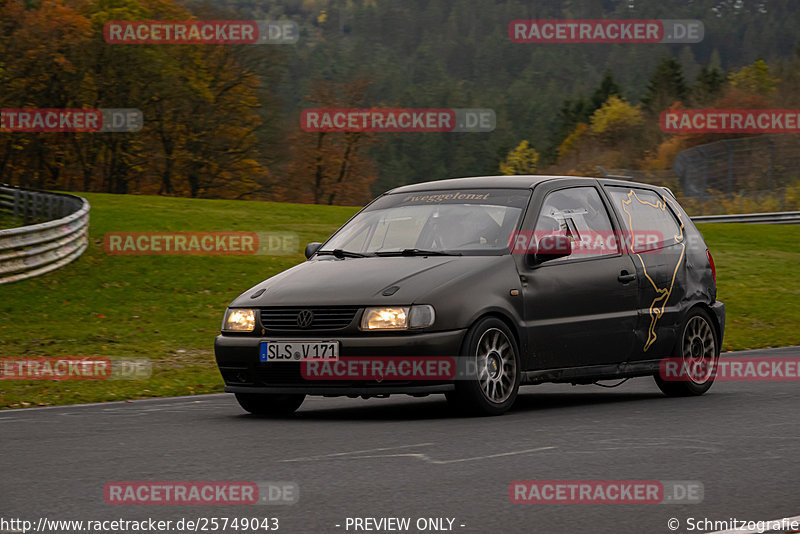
0;0;277;198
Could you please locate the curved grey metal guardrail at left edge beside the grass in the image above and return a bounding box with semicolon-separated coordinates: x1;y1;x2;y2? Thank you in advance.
0;184;89;285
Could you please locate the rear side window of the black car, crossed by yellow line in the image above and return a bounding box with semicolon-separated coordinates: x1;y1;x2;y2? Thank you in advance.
607;186;683;252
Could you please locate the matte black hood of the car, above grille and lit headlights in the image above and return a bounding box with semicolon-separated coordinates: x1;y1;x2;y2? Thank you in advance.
231;256;502;307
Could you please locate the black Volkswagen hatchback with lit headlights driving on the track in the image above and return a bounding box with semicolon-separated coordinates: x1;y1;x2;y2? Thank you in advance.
215;176;725;415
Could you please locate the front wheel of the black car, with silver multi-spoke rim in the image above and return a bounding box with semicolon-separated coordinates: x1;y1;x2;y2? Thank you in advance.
446;317;521;415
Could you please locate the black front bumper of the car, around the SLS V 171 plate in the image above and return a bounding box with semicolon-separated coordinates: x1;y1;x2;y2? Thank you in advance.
214;329;466;396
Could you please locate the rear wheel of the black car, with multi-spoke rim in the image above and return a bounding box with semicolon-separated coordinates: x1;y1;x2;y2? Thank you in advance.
654;308;720;397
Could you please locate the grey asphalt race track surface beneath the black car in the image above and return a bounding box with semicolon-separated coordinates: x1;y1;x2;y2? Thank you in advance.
0;347;800;534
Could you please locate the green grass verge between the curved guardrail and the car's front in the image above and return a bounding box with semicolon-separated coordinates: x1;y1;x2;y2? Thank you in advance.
0;194;357;408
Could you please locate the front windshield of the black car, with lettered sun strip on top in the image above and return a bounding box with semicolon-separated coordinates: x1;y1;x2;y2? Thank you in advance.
320;189;530;256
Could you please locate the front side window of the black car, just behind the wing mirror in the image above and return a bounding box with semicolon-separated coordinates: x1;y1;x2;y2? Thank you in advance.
534;187;619;263
